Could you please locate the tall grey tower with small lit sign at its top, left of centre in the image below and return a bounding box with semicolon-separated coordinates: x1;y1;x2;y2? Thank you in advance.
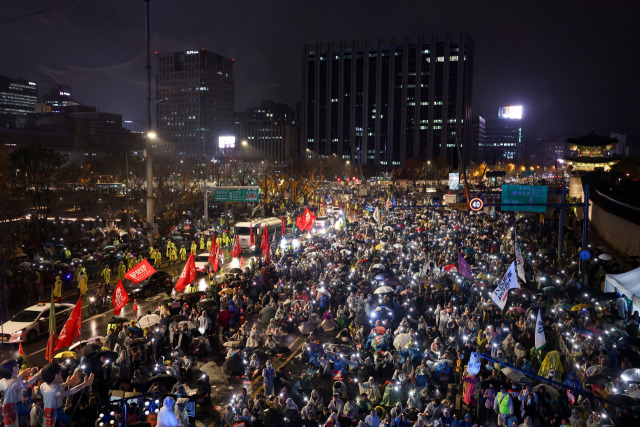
156;49;234;158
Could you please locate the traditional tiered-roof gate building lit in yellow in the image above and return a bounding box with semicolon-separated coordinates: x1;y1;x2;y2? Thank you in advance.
564;132;620;172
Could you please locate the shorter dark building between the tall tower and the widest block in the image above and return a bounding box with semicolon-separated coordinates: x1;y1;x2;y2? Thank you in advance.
235;101;298;162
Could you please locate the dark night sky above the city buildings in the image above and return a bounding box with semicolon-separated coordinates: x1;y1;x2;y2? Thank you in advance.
0;0;640;142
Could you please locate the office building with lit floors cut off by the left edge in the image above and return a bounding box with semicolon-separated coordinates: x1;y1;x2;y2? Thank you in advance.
0;76;38;127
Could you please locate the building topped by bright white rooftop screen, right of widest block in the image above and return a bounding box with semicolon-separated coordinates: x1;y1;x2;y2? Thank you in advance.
479;105;524;165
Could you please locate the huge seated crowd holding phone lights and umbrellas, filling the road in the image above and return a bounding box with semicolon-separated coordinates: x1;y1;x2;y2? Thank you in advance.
0;197;640;427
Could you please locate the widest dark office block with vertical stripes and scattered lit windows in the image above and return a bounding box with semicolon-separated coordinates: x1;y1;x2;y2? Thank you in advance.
301;33;473;170
